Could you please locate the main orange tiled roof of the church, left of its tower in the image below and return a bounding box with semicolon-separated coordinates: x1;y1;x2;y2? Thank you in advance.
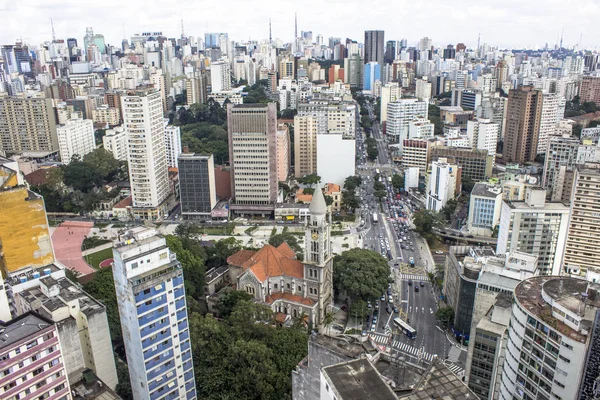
240;244;304;282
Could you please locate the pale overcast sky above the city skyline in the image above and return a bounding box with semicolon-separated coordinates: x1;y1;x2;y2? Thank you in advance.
0;0;600;49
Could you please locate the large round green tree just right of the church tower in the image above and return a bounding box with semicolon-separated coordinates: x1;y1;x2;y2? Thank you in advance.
333;249;390;301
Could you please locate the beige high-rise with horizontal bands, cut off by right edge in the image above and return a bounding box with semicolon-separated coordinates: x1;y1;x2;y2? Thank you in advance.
563;163;600;282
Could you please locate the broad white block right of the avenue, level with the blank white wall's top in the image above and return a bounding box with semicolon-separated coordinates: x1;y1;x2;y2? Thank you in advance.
386;99;429;153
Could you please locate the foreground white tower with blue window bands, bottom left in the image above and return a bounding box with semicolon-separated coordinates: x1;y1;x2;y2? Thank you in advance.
113;227;196;400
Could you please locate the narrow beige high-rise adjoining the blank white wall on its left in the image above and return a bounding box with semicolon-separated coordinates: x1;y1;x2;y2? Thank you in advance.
294;115;318;178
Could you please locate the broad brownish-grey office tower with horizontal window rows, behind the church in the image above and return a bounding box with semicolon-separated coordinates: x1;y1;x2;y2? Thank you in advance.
227;103;278;217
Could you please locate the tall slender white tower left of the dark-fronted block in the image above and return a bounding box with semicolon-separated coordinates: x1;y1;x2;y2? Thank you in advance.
121;89;169;220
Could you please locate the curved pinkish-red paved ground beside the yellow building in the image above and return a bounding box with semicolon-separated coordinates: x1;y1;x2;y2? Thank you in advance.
52;221;94;275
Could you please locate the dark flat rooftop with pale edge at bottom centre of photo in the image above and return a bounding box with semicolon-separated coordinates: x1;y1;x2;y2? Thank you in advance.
322;358;397;400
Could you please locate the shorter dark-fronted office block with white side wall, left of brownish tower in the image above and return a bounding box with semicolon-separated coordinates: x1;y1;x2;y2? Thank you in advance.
179;153;217;219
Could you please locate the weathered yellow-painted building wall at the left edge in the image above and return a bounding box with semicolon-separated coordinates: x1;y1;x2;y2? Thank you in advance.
0;157;54;276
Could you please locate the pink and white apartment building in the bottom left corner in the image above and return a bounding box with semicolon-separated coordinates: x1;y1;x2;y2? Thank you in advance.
0;312;71;400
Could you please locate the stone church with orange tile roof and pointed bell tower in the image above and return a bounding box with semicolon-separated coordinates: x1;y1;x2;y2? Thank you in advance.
227;188;333;326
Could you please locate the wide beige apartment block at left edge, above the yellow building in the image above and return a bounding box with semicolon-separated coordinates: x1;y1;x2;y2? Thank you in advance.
0;97;59;153
